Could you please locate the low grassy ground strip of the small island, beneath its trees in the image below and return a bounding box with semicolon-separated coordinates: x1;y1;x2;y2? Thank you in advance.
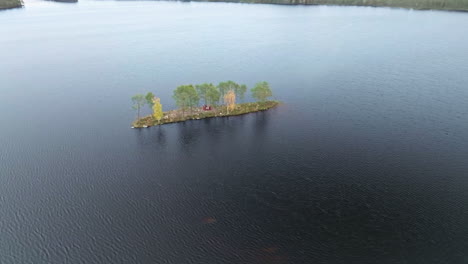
132;101;280;128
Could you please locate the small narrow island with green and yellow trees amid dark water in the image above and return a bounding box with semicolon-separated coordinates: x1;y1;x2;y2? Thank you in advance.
132;81;280;128
